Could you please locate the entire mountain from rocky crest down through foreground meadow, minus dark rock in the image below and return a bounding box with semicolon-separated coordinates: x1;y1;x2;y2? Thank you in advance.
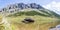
0;3;60;30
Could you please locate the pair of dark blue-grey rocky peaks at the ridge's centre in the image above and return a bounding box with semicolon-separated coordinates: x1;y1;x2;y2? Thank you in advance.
17;3;43;9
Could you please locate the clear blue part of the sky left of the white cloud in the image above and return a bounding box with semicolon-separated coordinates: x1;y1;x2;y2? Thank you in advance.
0;0;52;8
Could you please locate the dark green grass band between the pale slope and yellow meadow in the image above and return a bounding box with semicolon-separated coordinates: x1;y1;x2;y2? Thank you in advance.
8;11;49;17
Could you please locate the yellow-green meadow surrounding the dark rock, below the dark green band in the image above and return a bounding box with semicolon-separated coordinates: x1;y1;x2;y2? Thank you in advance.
7;15;60;30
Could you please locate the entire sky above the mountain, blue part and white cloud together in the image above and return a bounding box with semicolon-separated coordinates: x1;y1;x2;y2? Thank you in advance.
0;0;60;14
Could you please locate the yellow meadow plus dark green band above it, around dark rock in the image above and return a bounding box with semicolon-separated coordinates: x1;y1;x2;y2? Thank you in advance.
7;11;60;30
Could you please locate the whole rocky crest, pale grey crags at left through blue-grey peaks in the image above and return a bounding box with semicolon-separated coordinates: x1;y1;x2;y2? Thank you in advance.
2;3;44;13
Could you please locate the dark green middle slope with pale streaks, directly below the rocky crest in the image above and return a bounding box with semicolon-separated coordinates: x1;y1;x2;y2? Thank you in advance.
9;9;60;18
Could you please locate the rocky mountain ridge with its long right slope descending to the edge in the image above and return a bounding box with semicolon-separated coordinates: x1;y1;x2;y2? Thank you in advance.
0;3;60;17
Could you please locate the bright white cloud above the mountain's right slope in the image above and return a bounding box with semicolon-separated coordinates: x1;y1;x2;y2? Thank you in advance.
43;1;60;14
